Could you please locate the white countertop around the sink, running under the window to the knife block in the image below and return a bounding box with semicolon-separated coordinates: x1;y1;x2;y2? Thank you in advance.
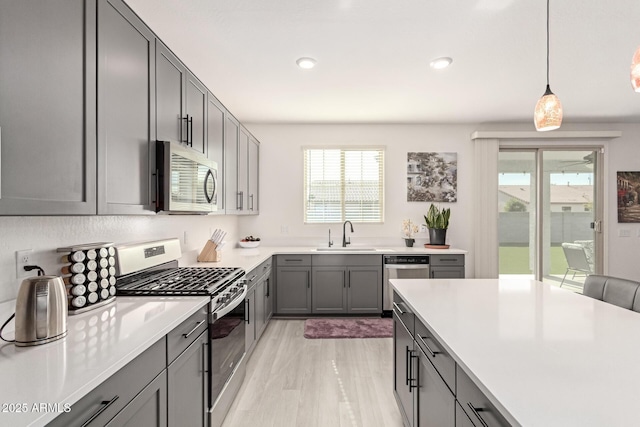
180;246;467;272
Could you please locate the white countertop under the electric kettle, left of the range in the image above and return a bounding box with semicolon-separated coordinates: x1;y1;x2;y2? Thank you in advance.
0;296;209;427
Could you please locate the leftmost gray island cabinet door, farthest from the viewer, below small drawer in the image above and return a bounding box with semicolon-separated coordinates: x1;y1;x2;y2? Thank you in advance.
393;312;414;427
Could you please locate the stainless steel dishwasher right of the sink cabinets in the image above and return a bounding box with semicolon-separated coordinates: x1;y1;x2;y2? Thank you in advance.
382;255;429;317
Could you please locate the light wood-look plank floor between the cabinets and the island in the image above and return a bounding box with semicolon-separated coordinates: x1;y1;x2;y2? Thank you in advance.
223;319;402;427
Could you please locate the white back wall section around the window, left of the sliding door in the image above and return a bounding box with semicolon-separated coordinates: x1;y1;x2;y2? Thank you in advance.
240;124;476;274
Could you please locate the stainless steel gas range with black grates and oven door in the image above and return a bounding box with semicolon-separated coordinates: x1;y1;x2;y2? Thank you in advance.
116;239;247;427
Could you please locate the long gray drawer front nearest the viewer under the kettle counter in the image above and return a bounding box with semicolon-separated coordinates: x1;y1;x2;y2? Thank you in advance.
48;337;167;427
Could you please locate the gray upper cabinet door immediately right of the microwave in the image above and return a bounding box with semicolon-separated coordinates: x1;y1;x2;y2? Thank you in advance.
207;92;225;214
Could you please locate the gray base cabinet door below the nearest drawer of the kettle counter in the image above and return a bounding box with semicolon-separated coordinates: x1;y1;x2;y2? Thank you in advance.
106;371;166;427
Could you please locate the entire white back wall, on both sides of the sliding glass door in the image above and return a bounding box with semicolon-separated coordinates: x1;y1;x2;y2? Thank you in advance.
245;123;640;280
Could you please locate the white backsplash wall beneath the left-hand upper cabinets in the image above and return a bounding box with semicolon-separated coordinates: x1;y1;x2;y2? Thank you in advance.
0;215;238;302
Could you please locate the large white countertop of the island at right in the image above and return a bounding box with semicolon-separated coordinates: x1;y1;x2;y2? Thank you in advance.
391;279;640;427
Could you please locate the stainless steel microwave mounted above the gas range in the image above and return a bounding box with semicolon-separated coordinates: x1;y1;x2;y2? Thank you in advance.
155;141;218;215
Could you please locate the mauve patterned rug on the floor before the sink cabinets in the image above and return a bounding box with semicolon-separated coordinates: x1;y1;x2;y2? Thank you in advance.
304;318;393;339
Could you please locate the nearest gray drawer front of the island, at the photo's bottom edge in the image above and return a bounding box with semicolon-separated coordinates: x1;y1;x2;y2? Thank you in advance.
456;366;510;427
